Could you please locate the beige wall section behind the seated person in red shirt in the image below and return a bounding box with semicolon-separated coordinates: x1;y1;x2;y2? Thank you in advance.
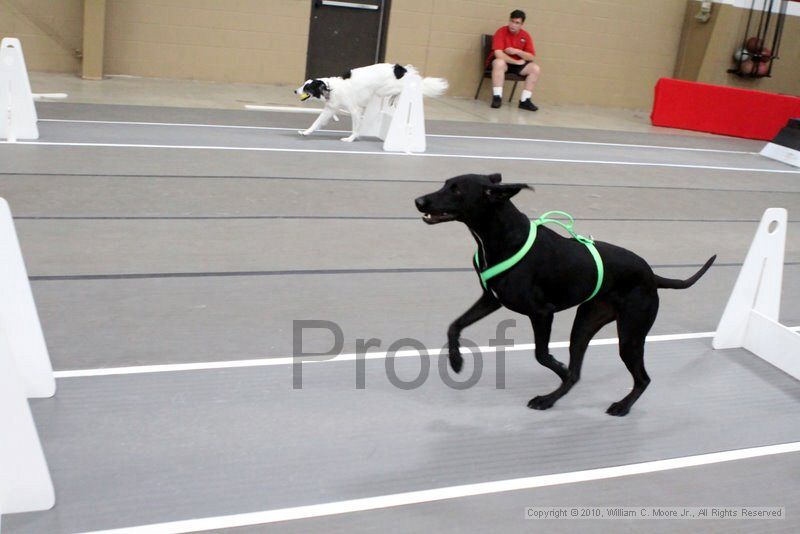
387;0;686;107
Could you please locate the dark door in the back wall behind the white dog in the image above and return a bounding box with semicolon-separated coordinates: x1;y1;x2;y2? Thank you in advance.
306;0;390;79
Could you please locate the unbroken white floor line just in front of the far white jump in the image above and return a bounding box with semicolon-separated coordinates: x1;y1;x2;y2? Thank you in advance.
0;141;800;174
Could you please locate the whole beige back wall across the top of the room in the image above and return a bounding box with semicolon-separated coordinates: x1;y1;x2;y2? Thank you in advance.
0;0;800;108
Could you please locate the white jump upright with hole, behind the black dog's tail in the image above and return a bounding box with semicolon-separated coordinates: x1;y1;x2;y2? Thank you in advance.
713;208;800;380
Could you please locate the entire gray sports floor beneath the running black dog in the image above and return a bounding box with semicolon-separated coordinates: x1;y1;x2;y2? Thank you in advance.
0;104;800;533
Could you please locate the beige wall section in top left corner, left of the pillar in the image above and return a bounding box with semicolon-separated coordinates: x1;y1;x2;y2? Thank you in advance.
0;0;83;72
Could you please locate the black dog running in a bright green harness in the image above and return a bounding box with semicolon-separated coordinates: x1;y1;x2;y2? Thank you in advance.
416;174;716;416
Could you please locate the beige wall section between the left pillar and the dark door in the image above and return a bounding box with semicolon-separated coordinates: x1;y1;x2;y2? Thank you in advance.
105;0;311;84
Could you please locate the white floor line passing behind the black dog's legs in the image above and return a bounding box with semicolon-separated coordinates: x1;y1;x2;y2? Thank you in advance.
53;326;800;378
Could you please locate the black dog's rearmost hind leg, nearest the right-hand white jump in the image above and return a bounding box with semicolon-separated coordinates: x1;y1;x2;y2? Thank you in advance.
606;289;658;417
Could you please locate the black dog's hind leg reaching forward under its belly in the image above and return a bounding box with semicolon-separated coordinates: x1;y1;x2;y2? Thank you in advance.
528;300;616;410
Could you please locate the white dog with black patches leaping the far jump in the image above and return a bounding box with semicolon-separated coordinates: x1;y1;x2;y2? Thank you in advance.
294;63;448;143
